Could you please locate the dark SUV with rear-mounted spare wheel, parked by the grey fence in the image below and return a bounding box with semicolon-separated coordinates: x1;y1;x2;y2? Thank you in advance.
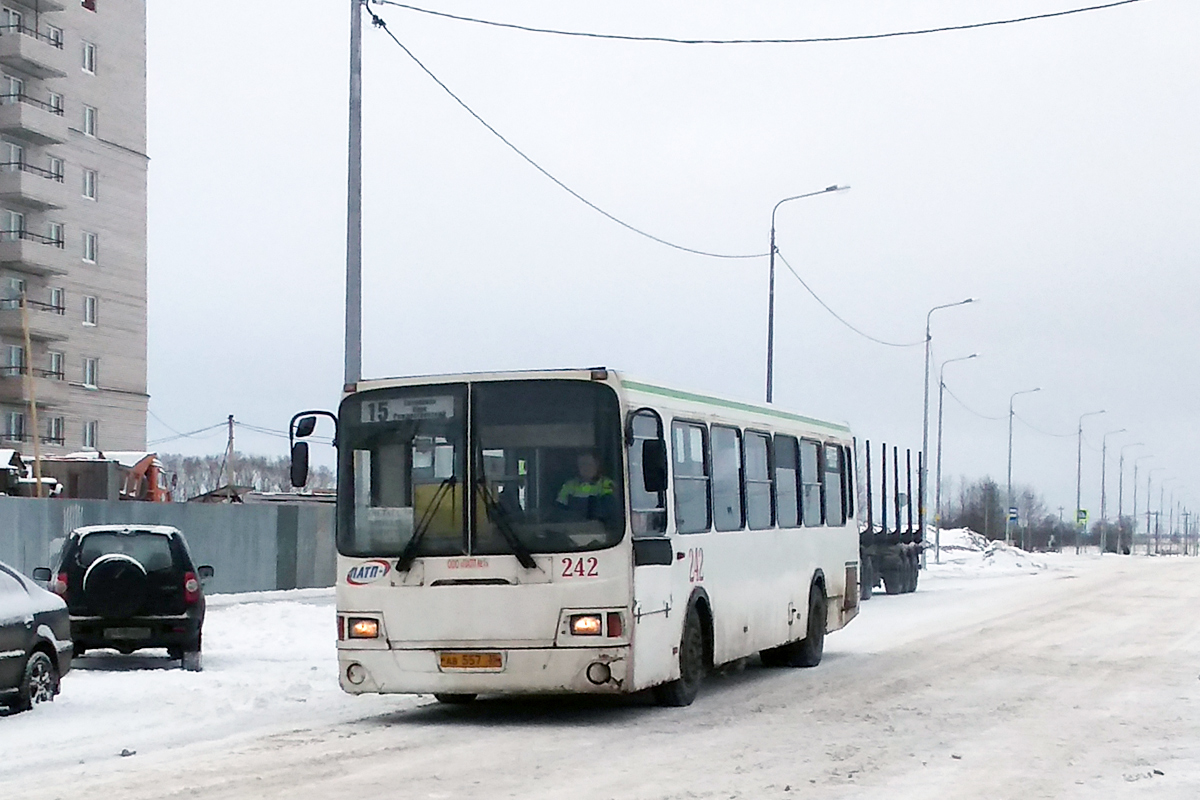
35;525;212;670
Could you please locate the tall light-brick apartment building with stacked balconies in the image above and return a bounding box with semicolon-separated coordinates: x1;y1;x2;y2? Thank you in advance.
0;0;148;455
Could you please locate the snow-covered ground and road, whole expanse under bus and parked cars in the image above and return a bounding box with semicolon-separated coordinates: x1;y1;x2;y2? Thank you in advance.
0;552;1200;800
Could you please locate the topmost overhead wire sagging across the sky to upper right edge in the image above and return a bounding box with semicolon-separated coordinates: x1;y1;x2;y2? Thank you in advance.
367;0;1141;44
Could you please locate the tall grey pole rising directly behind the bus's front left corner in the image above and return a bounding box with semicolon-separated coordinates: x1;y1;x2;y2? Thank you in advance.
345;0;362;388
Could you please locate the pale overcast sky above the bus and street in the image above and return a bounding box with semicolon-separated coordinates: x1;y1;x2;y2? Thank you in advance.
148;0;1200;519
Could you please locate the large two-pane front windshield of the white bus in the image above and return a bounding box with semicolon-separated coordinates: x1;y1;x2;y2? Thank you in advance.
337;380;625;557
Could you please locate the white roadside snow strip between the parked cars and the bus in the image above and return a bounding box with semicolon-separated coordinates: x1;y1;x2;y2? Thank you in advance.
0;589;417;777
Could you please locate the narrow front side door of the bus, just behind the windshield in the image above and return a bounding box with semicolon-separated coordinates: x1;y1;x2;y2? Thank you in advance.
625;409;679;688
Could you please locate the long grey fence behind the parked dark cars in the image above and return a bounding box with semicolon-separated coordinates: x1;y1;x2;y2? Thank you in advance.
0;497;337;594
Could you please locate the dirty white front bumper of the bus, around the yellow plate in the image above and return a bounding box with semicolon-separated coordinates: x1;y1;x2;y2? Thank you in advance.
337;645;630;694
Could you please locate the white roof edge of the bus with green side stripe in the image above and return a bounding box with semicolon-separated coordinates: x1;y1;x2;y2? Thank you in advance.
347;367;850;434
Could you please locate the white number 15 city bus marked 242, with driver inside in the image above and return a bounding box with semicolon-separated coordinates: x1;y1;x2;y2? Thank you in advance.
293;368;859;705
